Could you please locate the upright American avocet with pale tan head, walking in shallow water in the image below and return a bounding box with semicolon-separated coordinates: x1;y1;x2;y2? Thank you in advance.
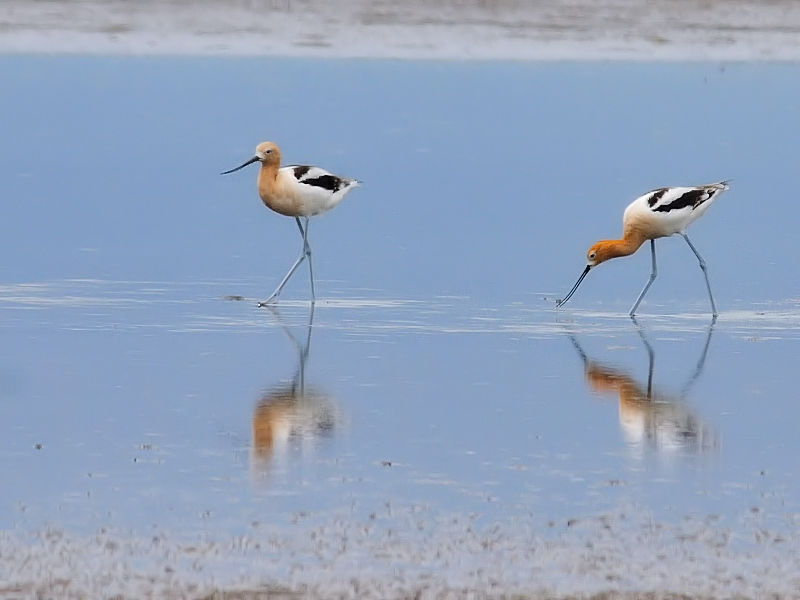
222;142;359;306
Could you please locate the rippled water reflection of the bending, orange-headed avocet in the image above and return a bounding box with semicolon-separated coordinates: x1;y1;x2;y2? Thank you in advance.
569;319;718;454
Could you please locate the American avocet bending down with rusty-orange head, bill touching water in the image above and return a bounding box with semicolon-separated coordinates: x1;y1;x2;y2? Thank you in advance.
556;181;728;317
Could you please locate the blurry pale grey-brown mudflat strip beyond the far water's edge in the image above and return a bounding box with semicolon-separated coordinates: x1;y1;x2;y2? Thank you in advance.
0;0;800;61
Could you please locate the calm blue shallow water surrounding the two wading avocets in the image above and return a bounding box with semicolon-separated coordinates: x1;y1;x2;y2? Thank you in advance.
0;57;800;596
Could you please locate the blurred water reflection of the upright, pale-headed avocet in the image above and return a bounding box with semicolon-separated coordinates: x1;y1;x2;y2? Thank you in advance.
250;303;340;474
